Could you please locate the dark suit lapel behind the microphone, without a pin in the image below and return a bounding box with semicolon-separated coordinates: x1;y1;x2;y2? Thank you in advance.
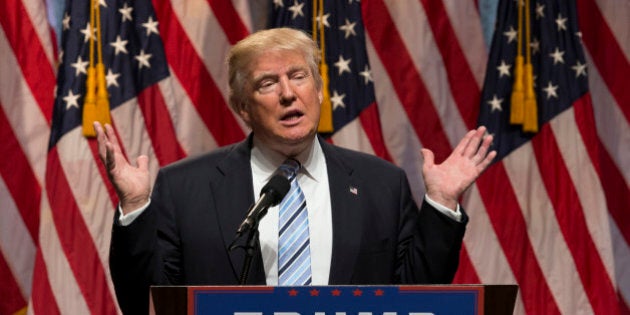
212;135;265;284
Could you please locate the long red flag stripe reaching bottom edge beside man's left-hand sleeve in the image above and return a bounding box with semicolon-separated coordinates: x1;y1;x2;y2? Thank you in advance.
46;146;117;314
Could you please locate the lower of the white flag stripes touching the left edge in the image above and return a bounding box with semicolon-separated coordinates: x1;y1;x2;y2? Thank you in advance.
0;177;36;299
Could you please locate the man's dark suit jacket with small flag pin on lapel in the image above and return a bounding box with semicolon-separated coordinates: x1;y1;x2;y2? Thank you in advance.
110;136;468;313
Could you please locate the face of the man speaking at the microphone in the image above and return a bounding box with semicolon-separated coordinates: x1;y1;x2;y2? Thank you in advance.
239;51;323;155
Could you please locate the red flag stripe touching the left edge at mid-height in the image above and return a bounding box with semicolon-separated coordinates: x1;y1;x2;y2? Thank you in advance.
0;105;42;241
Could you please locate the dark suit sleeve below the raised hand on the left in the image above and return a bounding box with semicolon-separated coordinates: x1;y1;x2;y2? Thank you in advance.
109;173;181;314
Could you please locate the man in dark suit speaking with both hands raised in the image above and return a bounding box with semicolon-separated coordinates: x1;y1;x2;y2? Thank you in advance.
95;28;496;313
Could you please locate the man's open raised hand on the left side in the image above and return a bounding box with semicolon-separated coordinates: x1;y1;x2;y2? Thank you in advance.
94;122;151;214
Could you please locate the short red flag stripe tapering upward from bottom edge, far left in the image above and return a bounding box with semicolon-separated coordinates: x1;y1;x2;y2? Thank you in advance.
31;247;61;315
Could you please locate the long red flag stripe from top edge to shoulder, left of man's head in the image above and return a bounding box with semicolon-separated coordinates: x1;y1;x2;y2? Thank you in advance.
155;1;245;146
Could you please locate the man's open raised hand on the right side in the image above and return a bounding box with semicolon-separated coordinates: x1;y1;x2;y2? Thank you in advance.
422;126;497;210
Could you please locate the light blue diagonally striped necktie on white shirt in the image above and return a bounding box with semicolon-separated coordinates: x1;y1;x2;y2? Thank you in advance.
278;159;311;286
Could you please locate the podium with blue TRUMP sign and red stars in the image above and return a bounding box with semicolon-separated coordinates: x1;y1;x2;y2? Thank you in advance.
149;285;518;315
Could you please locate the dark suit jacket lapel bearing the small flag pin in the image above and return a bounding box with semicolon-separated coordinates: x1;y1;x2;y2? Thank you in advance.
320;141;363;284
